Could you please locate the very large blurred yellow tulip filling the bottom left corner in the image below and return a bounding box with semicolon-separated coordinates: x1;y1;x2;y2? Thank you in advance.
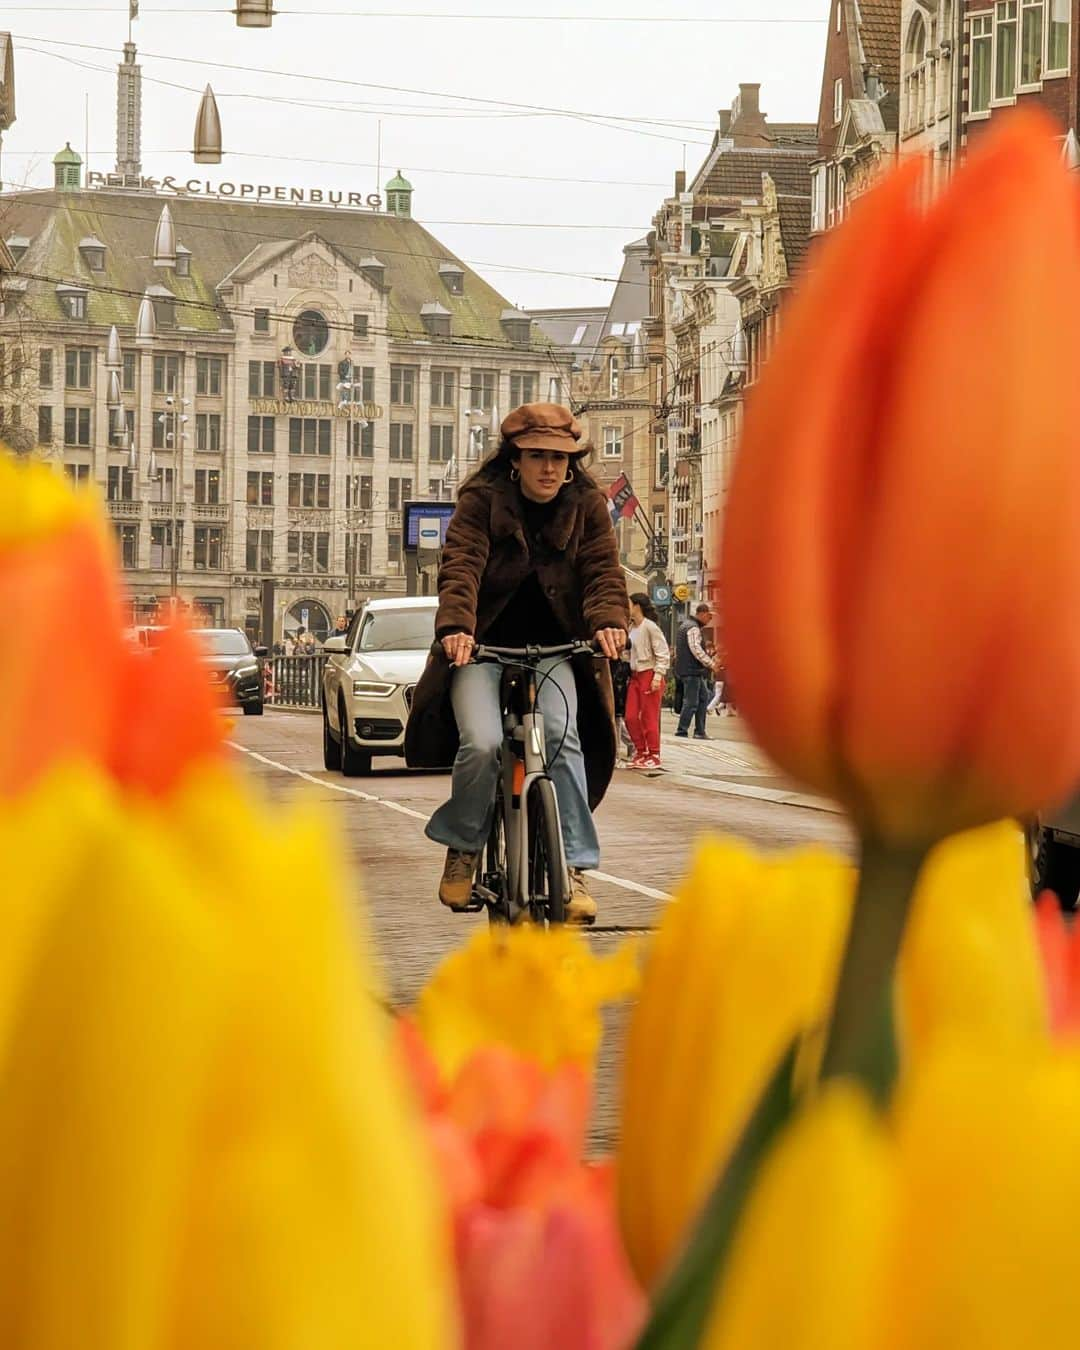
0;771;456;1350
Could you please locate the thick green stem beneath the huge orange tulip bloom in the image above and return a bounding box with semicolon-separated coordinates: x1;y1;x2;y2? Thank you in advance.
821;837;926;1102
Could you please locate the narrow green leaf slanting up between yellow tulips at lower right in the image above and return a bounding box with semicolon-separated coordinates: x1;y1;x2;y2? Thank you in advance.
637;1041;798;1350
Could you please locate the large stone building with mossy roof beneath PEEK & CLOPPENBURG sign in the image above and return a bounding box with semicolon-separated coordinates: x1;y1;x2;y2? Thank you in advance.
0;160;562;641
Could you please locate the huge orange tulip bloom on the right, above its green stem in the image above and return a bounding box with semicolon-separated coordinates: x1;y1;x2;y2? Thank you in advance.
722;113;1080;846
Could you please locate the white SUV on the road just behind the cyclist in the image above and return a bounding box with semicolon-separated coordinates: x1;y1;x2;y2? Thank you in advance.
323;595;439;778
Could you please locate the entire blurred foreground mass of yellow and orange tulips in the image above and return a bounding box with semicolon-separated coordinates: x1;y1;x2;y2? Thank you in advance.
0;110;1080;1350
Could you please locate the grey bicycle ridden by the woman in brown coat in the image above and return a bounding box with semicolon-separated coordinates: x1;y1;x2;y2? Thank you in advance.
467;641;597;923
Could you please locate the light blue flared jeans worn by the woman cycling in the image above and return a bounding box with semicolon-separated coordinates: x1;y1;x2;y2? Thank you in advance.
424;659;599;868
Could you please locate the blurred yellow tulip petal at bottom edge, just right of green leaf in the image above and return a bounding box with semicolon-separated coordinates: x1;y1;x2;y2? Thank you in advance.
702;1083;891;1350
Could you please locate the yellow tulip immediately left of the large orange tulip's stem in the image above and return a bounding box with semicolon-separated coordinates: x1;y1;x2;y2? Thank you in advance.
618;842;853;1287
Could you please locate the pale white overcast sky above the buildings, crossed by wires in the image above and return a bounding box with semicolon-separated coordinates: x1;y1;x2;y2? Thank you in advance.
0;0;829;308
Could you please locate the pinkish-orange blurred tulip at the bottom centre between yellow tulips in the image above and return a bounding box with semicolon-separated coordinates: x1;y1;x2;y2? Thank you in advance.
400;1023;644;1350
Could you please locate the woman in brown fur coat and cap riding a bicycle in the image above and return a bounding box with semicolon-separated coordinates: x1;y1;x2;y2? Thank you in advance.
405;404;628;923
